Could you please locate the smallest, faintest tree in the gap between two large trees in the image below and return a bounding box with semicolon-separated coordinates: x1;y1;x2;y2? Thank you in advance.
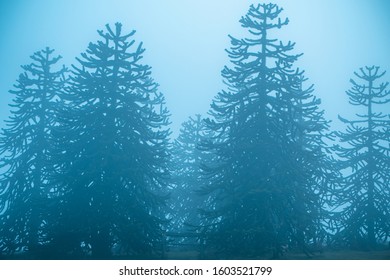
170;114;215;236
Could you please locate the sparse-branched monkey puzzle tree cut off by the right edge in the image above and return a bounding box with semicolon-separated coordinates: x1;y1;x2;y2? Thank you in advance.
334;66;390;249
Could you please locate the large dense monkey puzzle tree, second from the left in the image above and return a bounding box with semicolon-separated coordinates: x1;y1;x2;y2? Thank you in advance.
52;23;169;259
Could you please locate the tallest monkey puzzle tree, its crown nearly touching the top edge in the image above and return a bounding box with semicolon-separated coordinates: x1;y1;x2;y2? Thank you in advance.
198;4;328;257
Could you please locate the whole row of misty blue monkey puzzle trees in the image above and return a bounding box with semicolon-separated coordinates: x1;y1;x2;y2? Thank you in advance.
0;4;390;259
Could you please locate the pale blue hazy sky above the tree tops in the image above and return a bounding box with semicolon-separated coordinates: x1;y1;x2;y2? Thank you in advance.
0;0;390;136
